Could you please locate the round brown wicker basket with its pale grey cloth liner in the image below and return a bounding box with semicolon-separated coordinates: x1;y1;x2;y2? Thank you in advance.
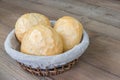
4;21;89;79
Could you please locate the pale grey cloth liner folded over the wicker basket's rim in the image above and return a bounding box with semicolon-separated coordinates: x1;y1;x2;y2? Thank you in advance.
4;21;89;69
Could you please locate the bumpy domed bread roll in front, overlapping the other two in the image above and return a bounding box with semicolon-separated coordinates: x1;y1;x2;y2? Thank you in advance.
21;24;63;56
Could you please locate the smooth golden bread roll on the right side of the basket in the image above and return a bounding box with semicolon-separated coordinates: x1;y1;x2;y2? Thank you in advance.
54;16;83;51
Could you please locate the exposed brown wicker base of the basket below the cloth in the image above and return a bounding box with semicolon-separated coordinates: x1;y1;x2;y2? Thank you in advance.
18;58;79;76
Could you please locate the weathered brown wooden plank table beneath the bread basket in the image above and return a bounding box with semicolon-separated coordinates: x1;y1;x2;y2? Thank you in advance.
0;0;120;80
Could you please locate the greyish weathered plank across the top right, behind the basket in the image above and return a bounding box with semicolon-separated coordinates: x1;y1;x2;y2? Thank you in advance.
15;0;120;27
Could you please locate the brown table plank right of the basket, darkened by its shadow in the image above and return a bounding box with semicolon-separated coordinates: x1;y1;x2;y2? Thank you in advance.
81;35;120;77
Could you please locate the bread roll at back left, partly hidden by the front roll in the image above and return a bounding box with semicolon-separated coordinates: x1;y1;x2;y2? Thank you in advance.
15;13;50;42
